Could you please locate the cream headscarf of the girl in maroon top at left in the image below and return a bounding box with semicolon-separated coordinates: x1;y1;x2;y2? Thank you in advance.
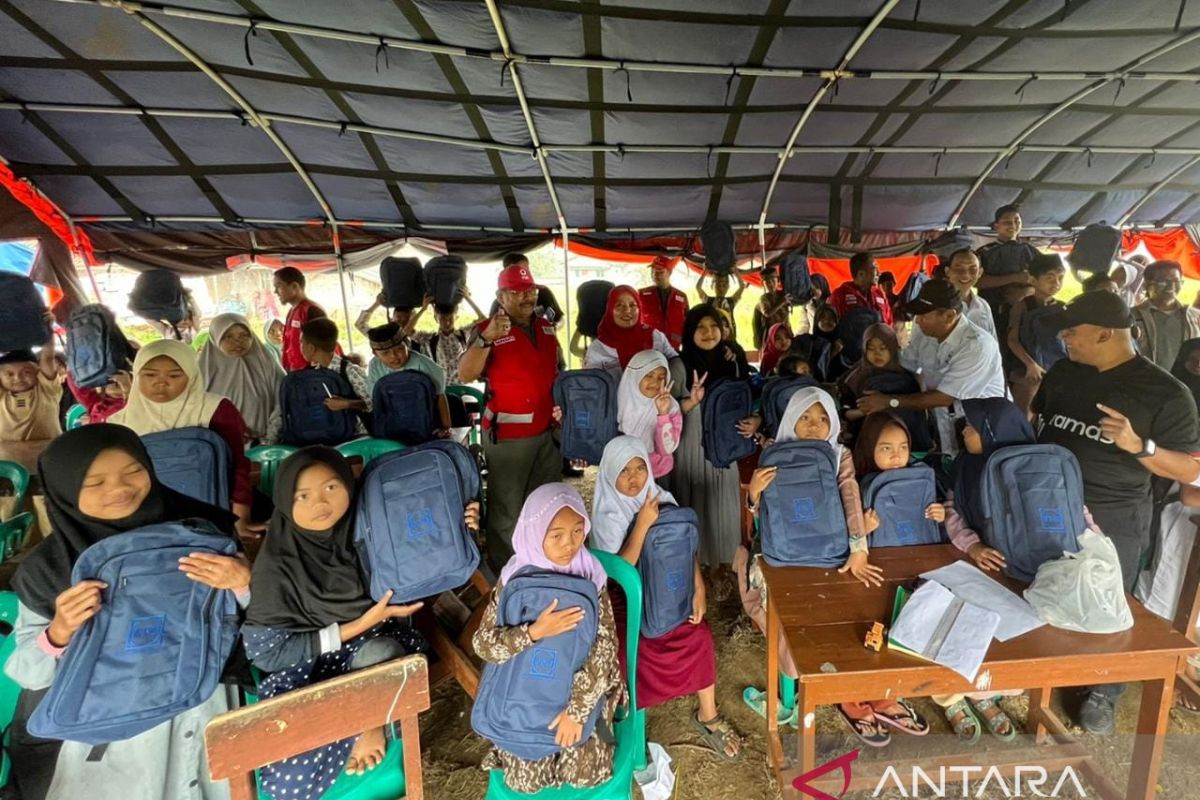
108;339;224;437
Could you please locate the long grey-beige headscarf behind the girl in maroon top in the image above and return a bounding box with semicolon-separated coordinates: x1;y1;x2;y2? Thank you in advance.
200;314;283;438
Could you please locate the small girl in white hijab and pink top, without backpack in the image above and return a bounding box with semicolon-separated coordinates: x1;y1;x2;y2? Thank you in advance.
617;350;683;477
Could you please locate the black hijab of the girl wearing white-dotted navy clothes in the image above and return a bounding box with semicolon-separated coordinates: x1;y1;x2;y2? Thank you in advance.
246;447;374;631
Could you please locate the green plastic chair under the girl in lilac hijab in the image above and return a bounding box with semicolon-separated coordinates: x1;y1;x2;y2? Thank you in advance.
487;551;646;800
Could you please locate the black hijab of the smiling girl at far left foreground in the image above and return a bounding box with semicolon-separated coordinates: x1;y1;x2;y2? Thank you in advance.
12;422;236;619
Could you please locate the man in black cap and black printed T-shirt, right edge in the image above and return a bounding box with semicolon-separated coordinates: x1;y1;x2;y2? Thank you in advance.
1032;291;1200;734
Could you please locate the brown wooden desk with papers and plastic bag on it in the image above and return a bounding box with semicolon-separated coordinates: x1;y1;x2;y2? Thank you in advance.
762;545;1198;800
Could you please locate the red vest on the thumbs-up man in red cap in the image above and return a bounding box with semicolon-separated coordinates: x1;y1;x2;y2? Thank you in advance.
476;317;558;439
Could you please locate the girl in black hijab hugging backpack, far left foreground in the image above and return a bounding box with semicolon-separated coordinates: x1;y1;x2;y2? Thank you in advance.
5;423;250;800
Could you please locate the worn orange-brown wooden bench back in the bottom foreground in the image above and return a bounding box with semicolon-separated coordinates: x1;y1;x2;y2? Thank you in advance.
204;656;430;800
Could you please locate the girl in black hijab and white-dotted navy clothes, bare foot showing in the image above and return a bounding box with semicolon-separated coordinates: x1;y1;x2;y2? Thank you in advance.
241;447;436;800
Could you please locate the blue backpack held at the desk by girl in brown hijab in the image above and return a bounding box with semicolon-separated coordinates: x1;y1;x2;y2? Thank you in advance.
863;464;942;549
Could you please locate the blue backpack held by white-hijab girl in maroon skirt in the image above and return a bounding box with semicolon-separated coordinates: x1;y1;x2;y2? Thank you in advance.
637;505;700;639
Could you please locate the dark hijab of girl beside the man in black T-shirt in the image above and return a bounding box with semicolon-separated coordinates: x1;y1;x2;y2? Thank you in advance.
953;397;1037;533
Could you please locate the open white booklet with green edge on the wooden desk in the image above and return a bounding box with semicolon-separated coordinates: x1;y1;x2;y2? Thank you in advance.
888;581;1000;682
